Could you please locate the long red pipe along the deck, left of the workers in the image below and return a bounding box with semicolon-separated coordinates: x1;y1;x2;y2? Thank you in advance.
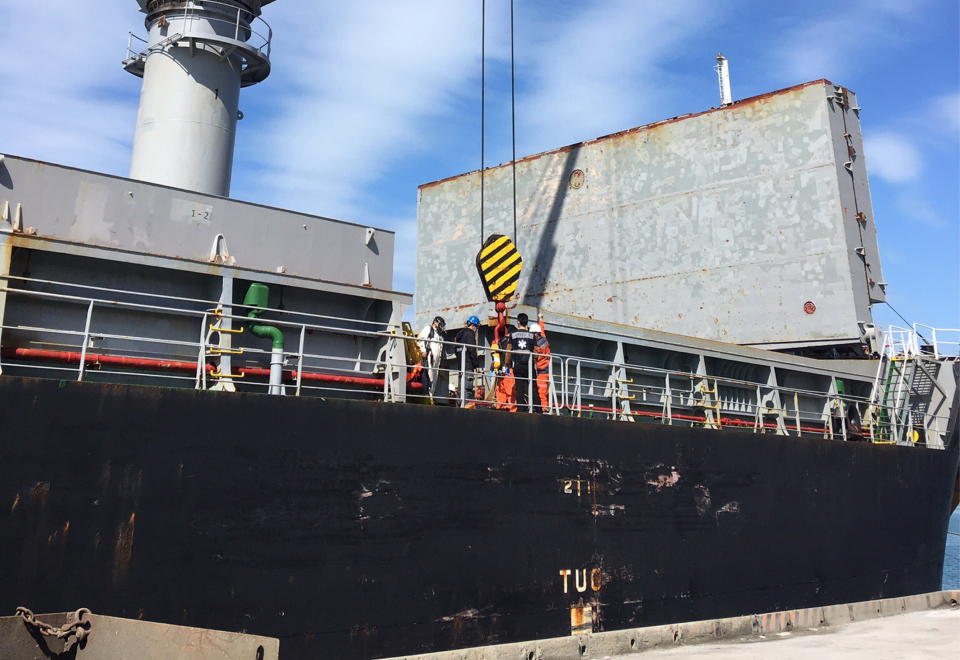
0;348;423;390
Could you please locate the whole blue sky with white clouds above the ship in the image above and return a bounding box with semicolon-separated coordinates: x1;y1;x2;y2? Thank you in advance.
0;0;960;328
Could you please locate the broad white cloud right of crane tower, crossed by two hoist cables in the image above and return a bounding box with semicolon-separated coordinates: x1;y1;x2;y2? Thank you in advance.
241;0;712;218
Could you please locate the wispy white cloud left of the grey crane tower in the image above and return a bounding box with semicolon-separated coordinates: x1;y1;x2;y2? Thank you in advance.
0;0;140;174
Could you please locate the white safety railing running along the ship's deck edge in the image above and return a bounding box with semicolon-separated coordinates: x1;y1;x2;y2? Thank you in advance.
0;276;949;446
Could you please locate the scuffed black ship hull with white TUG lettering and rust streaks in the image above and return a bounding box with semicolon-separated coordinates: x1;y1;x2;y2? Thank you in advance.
0;377;958;660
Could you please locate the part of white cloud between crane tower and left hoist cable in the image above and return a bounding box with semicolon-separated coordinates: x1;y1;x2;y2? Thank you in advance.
242;0;488;217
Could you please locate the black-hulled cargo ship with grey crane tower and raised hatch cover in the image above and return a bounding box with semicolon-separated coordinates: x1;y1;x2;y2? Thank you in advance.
0;0;960;660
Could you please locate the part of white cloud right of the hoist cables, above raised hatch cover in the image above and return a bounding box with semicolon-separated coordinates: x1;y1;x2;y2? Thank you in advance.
519;0;714;153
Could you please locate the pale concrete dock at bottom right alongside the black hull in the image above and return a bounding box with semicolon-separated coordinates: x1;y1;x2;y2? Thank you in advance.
394;591;960;660
